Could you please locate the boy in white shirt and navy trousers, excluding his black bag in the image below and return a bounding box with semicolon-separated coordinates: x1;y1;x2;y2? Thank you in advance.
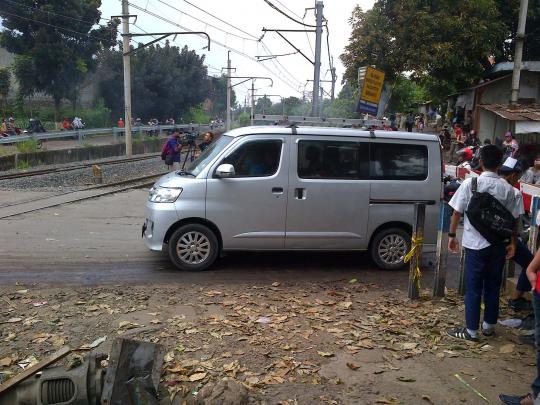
447;145;520;341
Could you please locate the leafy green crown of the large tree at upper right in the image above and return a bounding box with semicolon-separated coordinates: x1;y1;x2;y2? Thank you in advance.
341;0;520;101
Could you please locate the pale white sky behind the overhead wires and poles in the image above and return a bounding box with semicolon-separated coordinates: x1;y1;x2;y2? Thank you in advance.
101;0;374;104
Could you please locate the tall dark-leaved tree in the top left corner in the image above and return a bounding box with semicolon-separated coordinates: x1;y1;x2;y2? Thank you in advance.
0;0;118;116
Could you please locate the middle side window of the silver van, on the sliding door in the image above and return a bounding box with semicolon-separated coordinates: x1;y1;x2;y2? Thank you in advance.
298;140;369;180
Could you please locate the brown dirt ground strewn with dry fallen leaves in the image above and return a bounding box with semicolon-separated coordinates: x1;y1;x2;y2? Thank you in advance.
0;279;535;404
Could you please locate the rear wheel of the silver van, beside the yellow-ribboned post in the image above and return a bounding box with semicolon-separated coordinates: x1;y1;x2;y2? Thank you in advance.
371;228;411;270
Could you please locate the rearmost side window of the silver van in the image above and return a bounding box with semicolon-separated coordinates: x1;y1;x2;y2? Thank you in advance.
370;142;428;180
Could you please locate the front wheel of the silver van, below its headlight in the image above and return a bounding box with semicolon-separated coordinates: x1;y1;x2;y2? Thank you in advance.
169;224;219;271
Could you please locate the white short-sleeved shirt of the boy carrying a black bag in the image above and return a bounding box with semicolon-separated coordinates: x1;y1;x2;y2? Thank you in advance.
449;172;523;250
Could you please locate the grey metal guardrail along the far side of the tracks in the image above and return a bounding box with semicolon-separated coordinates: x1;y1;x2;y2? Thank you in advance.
0;124;223;145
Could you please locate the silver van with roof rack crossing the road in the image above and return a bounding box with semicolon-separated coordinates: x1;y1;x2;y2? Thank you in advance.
142;126;442;270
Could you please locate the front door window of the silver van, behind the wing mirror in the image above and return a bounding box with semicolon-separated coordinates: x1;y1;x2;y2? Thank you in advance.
221;139;282;177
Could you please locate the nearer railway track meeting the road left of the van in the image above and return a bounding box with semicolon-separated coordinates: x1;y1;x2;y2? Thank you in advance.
0;171;170;219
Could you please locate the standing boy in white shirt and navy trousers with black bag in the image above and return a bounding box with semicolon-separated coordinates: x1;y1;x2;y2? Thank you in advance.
447;145;520;341
